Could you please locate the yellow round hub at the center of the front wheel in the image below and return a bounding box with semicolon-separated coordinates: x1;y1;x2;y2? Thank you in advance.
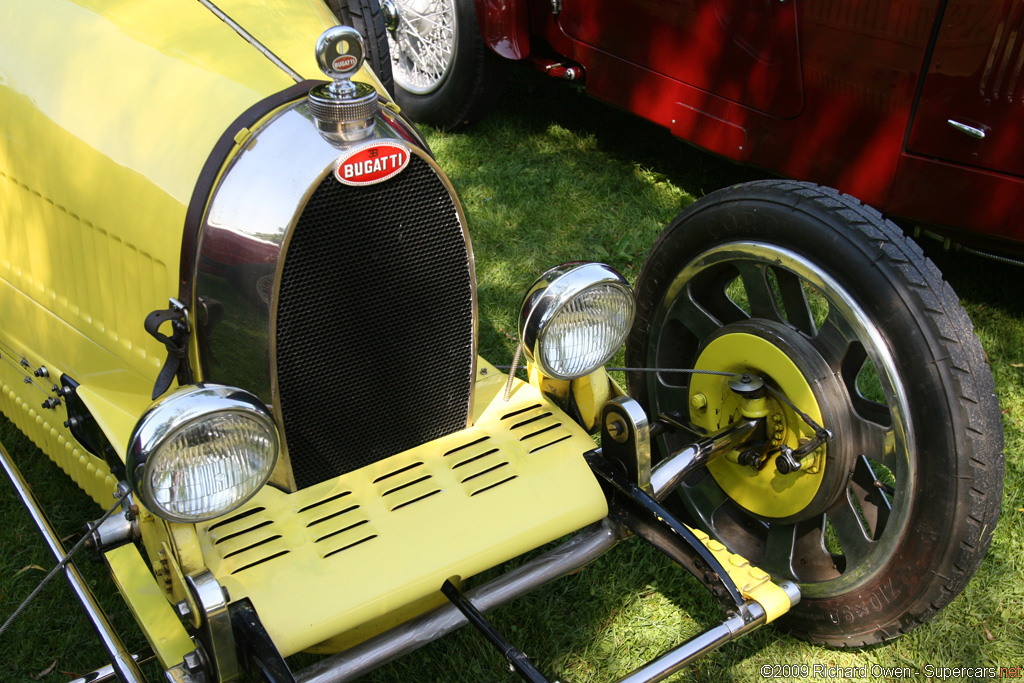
689;321;855;523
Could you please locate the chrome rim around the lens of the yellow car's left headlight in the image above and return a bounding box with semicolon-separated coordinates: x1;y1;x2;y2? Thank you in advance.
127;383;281;523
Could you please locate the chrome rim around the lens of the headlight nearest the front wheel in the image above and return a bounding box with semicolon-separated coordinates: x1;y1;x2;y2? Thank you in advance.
519;261;636;380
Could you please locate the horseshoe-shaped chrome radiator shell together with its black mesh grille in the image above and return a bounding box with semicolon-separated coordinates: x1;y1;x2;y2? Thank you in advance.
193;101;477;490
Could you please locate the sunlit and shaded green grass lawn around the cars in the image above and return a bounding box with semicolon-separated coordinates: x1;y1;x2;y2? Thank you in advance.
0;65;1024;683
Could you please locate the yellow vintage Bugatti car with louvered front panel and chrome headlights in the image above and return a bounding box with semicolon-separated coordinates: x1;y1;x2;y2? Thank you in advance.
0;0;1002;683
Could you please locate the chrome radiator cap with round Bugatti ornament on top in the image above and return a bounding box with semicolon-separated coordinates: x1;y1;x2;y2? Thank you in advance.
309;26;379;146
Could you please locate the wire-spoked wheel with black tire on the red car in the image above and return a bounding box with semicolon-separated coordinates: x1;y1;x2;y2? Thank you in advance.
388;0;506;130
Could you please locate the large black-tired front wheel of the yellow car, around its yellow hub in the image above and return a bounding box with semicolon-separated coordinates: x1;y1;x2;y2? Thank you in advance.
627;180;1004;646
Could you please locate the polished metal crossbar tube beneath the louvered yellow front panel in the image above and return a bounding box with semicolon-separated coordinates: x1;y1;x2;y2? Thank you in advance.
295;518;621;683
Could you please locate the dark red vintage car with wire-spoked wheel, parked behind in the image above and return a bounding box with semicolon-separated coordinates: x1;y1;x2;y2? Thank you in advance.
364;0;1024;254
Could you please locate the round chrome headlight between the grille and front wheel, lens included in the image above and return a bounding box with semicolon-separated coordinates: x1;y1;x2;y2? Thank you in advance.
519;263;636;380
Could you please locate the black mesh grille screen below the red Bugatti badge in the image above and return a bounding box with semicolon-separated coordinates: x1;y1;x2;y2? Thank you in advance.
274;156;475;488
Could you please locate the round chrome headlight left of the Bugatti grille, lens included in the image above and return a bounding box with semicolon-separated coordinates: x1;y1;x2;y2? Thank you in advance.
128;384;280;522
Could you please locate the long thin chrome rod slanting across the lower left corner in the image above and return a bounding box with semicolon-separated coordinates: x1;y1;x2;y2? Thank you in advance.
0;443;145;683
